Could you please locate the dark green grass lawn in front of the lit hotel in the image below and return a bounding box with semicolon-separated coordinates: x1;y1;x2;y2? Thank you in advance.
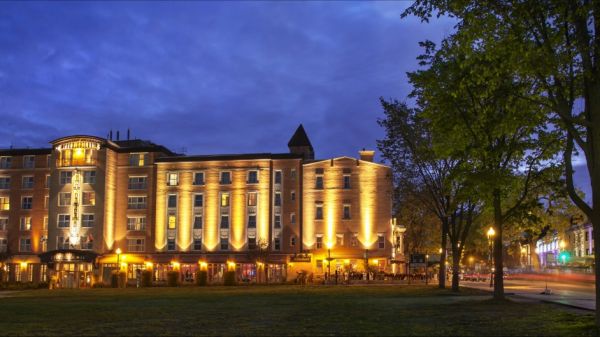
0;286;593;336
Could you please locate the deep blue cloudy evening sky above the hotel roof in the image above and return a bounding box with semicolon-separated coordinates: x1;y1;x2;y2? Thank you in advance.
0;1;592;197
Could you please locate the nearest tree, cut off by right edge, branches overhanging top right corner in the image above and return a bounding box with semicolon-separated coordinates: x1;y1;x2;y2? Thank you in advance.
403;0;600;318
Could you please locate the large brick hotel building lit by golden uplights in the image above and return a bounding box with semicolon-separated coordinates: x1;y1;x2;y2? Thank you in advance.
0;126;404;287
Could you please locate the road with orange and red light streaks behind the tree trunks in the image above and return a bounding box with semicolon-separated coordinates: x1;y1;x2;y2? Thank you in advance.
461;277;596;310
